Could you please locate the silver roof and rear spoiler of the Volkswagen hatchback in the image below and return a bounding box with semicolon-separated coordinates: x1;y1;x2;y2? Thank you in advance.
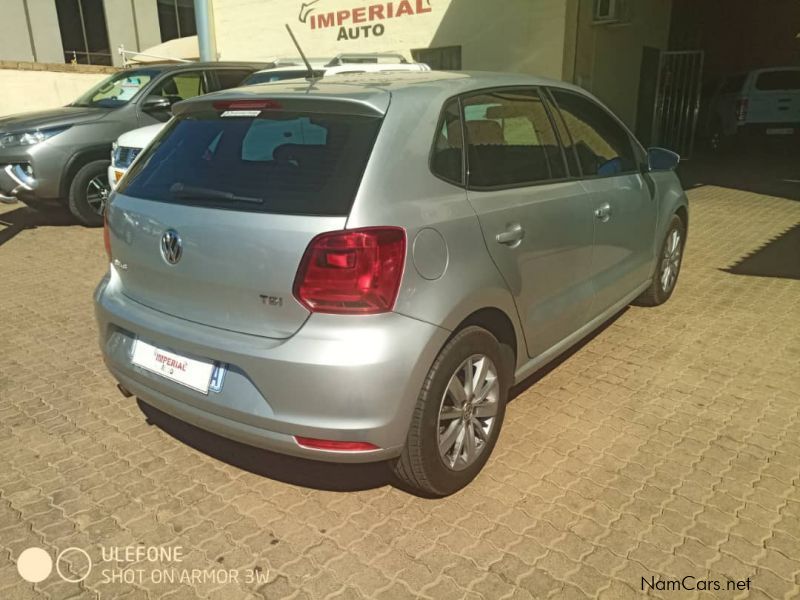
174;71;586;114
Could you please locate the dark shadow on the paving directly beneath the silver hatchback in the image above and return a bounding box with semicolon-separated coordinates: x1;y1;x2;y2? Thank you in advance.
137;308;628;499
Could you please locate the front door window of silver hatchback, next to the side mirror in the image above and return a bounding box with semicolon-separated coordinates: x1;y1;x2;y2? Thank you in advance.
553;90;638;177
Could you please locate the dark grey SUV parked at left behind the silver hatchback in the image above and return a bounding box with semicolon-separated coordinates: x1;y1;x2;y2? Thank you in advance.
0;62;269;225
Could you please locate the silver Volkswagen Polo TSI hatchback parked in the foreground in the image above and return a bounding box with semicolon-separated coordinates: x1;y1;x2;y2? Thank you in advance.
95;72;688;496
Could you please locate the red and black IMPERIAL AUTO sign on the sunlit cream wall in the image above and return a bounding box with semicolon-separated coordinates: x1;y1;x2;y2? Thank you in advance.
298;0;432;41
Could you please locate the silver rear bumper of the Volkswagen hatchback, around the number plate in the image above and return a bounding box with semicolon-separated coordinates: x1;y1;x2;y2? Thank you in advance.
95;269;449;462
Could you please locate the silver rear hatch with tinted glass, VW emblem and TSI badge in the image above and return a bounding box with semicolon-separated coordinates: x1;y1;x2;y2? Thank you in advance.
108;93;388;338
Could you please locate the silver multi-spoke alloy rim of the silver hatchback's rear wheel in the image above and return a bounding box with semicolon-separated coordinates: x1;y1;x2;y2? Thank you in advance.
436;354;500;471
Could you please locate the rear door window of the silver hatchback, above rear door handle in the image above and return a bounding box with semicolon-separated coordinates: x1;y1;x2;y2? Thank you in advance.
464;91;566;187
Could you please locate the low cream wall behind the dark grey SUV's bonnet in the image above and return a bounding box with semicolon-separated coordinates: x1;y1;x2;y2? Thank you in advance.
0;69;109;116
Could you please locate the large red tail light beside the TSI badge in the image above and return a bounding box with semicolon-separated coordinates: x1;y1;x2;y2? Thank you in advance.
294;227;406;315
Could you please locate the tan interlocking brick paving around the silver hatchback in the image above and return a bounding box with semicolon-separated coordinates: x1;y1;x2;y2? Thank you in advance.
0;161;800;600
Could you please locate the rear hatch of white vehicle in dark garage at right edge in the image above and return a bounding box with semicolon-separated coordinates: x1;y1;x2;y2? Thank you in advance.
747;69;800;125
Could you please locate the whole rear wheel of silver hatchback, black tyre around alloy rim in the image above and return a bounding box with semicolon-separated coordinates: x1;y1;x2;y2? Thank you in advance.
393;326;513;497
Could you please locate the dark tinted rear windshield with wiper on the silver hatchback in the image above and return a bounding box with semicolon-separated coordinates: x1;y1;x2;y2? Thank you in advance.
119;110;381;216
